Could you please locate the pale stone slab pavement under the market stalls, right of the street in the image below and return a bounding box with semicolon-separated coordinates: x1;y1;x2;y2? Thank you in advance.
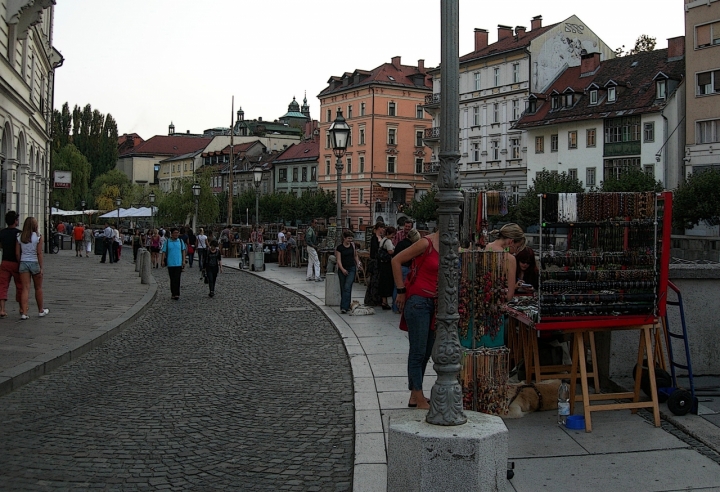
226;259;720;492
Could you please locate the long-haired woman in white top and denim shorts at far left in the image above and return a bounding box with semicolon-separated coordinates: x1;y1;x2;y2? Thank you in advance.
15;217;50;320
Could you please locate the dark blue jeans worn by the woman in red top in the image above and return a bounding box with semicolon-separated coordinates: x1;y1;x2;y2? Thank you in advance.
403;296;435;391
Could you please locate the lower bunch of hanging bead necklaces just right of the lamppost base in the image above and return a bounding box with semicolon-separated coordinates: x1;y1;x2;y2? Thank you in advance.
459;347;510;416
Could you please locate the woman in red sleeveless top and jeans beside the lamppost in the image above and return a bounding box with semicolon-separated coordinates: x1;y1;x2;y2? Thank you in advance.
391;233;440;409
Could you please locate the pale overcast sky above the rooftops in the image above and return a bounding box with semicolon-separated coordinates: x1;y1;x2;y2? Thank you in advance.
53;0;684;140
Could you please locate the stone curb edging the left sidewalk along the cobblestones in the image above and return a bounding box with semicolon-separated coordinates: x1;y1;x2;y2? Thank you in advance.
0;277;157;396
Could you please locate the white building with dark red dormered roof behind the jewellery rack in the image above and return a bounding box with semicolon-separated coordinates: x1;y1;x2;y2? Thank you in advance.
513;42;685;189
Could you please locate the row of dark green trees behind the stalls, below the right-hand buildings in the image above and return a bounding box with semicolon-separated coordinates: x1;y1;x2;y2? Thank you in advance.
407;169;720;233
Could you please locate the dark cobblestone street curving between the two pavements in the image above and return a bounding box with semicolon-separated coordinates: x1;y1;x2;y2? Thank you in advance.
0;268;354;491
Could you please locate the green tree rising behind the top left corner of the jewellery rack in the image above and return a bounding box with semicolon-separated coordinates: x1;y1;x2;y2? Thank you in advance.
506;169;585;228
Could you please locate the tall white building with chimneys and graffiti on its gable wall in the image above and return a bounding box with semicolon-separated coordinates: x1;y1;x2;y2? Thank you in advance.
425;16;615;194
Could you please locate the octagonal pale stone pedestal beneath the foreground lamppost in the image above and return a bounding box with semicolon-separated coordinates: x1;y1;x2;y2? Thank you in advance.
387;410;508;492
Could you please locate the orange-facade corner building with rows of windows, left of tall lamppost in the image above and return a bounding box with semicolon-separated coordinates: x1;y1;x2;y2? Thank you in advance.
318;56;432;230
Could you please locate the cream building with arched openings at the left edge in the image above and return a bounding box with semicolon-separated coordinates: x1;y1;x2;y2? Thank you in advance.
0;0;63;230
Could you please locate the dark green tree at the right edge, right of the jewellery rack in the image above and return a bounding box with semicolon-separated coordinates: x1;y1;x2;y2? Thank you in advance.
673;168;720;229
